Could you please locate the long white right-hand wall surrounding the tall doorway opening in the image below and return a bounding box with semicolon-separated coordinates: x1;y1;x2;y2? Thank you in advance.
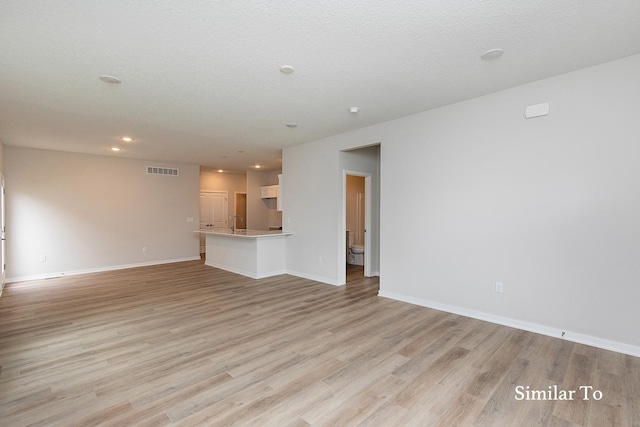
283;55;640;355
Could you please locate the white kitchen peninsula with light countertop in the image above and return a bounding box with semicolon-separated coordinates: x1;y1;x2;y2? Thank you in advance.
196;229;291;279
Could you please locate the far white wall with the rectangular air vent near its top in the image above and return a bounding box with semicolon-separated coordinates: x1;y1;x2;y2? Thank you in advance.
5;146;199;280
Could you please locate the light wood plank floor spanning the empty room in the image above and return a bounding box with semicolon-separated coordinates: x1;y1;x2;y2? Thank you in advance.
0;261;640;426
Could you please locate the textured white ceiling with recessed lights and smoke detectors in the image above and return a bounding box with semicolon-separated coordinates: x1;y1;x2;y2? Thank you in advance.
0;0;640;170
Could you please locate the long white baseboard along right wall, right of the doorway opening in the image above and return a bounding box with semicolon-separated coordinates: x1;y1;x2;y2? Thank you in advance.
378;290;640;357
